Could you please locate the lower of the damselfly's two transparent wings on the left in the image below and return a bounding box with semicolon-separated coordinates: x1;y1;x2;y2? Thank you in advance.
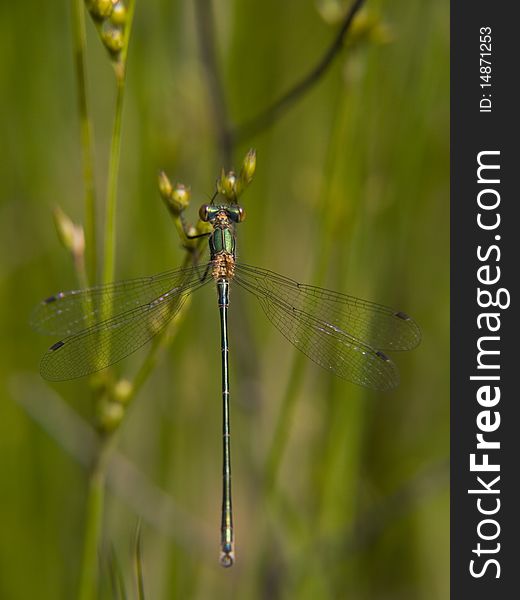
40;266;211;381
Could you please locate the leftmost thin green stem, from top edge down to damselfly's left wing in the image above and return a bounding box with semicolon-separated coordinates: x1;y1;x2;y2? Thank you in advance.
72;0;97;284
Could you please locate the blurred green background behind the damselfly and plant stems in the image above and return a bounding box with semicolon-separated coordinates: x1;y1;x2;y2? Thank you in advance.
0;0;449;600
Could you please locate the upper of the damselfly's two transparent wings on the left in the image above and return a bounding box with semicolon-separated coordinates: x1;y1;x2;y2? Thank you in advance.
30;264;207;336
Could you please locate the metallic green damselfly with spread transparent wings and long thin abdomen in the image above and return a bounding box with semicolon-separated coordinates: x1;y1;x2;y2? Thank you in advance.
33;164;420;567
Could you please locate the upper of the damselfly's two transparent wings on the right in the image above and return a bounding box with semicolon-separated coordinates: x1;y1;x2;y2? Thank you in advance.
236;264;421;351
